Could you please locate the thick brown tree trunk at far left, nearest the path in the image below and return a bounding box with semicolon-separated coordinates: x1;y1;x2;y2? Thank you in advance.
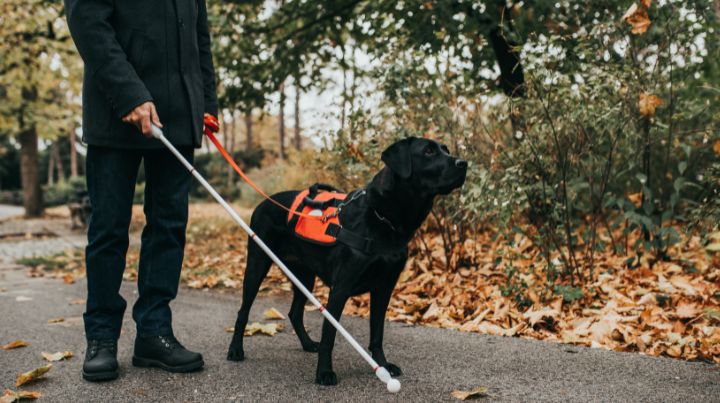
18;126;43;217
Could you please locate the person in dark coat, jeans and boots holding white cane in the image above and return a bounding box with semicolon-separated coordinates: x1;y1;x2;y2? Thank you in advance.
65;0;217;381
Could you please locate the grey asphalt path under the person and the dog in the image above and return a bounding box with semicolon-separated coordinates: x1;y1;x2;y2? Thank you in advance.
0;265;720;402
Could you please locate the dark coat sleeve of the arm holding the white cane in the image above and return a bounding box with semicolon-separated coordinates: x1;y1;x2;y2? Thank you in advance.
65;0;152;118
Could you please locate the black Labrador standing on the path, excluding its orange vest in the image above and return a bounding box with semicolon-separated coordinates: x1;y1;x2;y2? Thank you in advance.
227;137;467;385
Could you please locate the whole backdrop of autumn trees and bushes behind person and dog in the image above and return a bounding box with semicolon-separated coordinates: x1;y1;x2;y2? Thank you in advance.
0;0;720;290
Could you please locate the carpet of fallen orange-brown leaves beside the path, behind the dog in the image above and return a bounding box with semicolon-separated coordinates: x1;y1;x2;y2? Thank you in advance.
25;204;720;364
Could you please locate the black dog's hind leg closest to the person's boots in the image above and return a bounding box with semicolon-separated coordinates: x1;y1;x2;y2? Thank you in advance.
227;241;272;361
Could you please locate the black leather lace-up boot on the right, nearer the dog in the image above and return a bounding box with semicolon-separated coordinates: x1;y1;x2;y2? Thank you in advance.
133;335;205;372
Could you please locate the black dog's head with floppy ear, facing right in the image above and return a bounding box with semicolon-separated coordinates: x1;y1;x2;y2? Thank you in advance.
382;137;468;195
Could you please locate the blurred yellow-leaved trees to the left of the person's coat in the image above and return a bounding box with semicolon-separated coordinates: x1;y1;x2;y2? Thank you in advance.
0;0;81;217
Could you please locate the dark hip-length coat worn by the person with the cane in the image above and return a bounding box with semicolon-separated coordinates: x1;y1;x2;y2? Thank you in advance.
65;0;217;148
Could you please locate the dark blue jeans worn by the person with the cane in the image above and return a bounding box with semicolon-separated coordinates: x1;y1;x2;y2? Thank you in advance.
83;145;193;340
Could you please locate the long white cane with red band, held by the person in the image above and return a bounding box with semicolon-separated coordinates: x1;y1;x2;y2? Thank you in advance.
152;125;400;393
